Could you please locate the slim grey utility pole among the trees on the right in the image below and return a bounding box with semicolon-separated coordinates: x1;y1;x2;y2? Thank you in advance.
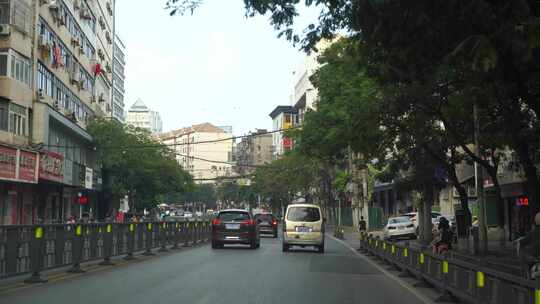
473;102;488;254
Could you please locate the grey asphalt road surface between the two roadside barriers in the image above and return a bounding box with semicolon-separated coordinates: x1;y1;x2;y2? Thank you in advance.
0;237;428;304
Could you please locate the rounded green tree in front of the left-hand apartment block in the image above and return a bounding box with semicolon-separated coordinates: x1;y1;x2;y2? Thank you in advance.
88;119;192;210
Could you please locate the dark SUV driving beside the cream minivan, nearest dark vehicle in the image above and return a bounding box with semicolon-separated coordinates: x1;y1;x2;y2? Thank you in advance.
212;209;261;249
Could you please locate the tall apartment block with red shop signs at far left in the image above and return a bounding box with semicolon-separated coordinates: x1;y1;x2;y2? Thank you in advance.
0;0;114;224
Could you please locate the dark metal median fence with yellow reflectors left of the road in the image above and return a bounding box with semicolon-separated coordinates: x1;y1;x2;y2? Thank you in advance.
0;218;211;284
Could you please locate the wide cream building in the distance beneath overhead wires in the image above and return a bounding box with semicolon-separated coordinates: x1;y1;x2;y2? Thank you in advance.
159;123;233;183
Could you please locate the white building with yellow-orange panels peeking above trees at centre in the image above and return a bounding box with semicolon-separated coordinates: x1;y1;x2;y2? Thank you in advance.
270;106;298;159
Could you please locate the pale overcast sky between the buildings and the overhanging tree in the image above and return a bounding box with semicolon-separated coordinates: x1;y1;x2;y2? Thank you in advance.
116;0;316;135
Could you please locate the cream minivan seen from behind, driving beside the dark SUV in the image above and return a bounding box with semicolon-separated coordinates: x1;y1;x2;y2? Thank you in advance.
282;204;324;253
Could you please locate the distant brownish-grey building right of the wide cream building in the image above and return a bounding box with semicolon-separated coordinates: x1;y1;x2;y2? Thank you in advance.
235;129;273;175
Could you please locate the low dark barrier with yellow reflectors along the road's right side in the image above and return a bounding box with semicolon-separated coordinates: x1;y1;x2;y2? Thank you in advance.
360;233;540;304
